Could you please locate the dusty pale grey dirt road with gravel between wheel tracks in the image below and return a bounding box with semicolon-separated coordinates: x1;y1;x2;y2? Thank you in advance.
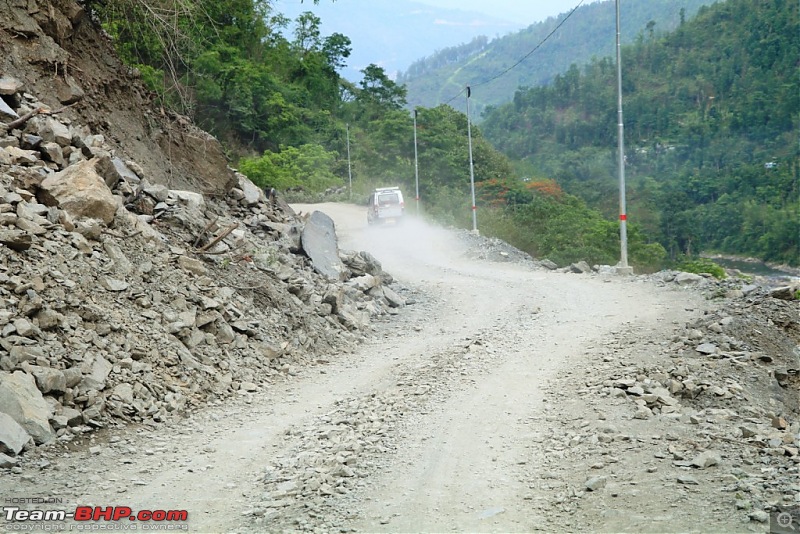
0;205;700;532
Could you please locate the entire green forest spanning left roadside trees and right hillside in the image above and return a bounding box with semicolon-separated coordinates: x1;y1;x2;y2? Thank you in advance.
88;0;798;270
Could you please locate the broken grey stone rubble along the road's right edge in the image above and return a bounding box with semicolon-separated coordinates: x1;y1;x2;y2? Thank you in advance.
546;288;800;524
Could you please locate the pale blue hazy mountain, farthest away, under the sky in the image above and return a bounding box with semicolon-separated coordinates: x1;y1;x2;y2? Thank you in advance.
273;0;524;81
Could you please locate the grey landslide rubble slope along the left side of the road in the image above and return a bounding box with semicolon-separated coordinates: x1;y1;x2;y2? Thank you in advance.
0;74;412;466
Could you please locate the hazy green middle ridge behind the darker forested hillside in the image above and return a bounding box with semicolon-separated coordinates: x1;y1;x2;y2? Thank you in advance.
404;0;715;118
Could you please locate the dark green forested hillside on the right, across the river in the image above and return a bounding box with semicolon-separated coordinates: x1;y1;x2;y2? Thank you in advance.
482;0;800;265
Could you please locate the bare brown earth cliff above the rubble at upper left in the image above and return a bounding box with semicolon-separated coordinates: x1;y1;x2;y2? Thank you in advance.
0;0;236;195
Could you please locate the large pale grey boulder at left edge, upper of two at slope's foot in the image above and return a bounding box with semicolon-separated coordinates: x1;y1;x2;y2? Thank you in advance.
0;371;55;444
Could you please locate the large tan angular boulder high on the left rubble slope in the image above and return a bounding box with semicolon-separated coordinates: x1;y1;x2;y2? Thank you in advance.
39;158;118;224
